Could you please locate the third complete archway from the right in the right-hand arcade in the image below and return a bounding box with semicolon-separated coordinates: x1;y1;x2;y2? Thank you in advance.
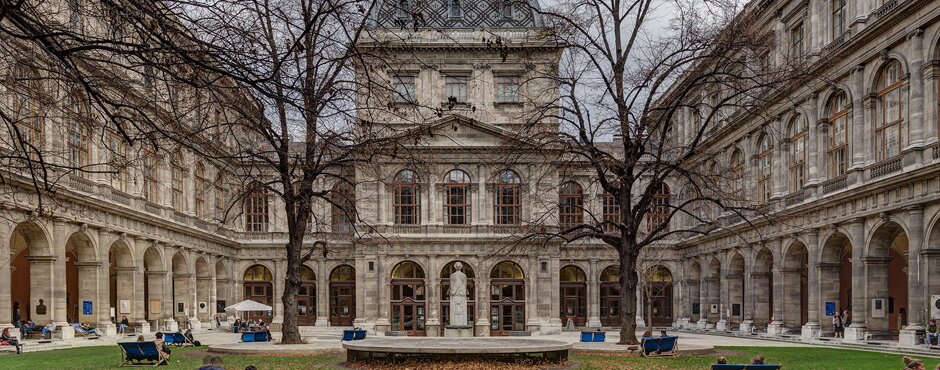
783;242;809;330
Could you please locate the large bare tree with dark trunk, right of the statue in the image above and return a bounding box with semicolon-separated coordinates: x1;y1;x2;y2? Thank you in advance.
506;0;806;344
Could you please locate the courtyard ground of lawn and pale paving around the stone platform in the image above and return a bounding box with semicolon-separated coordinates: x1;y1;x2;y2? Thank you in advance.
0;331;940;370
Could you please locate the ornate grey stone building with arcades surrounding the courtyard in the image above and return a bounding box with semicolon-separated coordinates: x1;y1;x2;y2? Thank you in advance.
0;0;940;343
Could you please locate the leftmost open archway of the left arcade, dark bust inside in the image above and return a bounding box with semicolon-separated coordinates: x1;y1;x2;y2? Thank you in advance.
10;222;54;325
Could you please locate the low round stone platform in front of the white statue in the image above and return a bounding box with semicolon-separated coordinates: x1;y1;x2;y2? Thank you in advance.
343;338;571;363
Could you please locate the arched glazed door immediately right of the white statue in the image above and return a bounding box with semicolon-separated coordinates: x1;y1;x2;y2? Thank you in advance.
490;261;525;336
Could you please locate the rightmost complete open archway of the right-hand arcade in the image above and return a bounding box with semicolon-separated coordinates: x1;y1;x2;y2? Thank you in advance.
872;222;908;333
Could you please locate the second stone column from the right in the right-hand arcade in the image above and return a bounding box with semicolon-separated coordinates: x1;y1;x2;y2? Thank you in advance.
845;218;868;342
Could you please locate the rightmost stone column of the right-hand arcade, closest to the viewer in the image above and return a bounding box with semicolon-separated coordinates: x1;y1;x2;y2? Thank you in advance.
898;205;930;347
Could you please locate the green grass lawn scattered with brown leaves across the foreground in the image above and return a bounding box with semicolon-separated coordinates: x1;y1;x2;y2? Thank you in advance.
0;346;940;370
